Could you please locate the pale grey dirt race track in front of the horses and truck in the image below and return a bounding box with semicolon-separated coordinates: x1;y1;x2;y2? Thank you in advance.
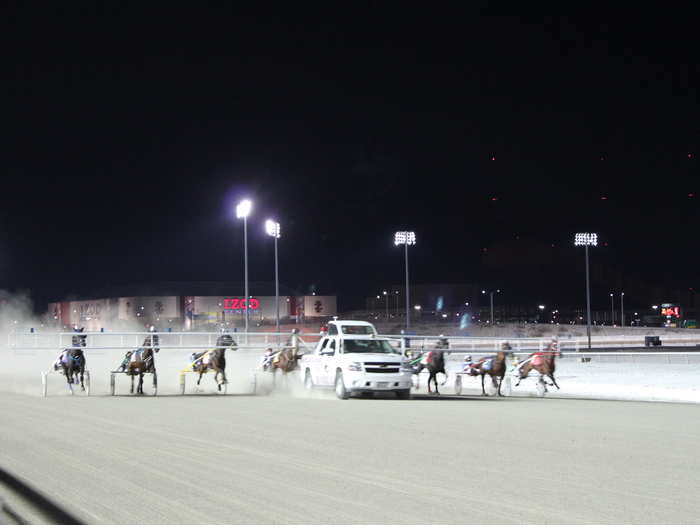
0;393;700;524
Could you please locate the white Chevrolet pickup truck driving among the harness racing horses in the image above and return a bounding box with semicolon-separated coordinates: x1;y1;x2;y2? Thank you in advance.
300;321;412;399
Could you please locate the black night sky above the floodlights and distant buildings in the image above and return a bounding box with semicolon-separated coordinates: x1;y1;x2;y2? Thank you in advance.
0;3;700;308
